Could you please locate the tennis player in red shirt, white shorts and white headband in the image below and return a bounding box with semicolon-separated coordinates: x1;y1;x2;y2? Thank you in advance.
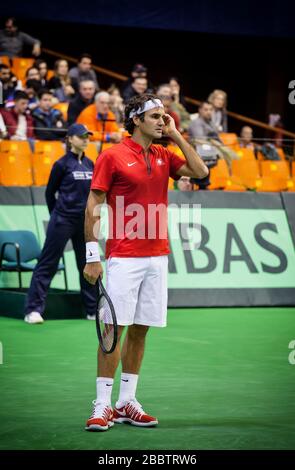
84;94;208;431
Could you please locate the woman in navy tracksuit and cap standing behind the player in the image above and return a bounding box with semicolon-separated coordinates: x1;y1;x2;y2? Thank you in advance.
25;124;96;323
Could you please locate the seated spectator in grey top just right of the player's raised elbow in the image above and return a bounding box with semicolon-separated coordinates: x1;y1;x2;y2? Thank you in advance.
189;101;239;169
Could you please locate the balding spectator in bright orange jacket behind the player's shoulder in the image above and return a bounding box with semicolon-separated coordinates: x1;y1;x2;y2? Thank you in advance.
77;91;122;144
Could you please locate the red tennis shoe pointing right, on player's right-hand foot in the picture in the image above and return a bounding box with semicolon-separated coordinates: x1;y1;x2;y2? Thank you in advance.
113;398;158;427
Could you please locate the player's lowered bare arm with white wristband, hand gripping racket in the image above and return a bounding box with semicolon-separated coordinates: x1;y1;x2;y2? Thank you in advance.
83;189;106;284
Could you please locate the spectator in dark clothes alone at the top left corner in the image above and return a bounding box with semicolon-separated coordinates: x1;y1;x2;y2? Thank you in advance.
0;18;41;58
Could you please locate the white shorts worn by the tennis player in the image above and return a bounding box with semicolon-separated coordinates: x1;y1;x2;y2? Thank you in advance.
106;255;168;327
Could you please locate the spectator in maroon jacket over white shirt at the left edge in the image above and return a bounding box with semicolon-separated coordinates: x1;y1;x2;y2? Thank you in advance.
1;91;34;140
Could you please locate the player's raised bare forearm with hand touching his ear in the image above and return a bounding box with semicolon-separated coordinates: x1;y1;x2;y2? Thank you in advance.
163;114;209;178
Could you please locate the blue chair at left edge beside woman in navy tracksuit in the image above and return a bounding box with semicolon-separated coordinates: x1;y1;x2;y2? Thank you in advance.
0;230;68;290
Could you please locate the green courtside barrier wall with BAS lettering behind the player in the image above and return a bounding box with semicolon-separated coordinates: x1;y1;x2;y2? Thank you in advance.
0;187;295;307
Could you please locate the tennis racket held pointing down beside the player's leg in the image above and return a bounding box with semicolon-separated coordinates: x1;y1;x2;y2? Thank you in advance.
95;277;118;354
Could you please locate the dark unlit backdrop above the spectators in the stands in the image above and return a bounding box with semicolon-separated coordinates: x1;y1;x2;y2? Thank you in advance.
1;0;295;137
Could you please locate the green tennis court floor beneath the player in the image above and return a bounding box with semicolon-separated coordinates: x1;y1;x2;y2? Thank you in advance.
0;308;295;450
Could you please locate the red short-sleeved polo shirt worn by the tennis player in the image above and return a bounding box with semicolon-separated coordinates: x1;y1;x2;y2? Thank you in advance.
91;137;185;258
